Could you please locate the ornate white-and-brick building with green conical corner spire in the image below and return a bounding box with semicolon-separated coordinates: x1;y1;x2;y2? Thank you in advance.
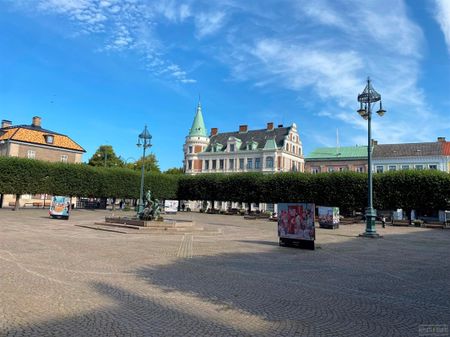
183;102;304;174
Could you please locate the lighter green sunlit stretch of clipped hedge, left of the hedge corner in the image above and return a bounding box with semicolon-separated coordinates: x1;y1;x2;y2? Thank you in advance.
0;157;178;199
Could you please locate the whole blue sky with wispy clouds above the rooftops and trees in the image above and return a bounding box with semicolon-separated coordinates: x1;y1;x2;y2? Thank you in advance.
0;0;450;169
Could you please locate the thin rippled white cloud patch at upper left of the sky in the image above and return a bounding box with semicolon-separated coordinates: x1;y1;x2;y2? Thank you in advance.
22;0;195;83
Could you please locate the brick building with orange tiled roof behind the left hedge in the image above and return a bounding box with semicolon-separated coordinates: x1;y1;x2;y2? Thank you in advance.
0;116;86;207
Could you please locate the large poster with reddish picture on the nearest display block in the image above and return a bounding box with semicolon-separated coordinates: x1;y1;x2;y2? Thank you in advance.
278;203;316;241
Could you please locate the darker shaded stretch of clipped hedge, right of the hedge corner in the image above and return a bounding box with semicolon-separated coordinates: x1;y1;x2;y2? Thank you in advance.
178;170;450;212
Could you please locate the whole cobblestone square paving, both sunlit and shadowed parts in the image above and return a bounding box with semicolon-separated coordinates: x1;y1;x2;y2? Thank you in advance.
0;209;450;337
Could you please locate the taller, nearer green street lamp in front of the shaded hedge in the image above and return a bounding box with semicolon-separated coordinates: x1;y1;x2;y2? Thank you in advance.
358;78;386;238
